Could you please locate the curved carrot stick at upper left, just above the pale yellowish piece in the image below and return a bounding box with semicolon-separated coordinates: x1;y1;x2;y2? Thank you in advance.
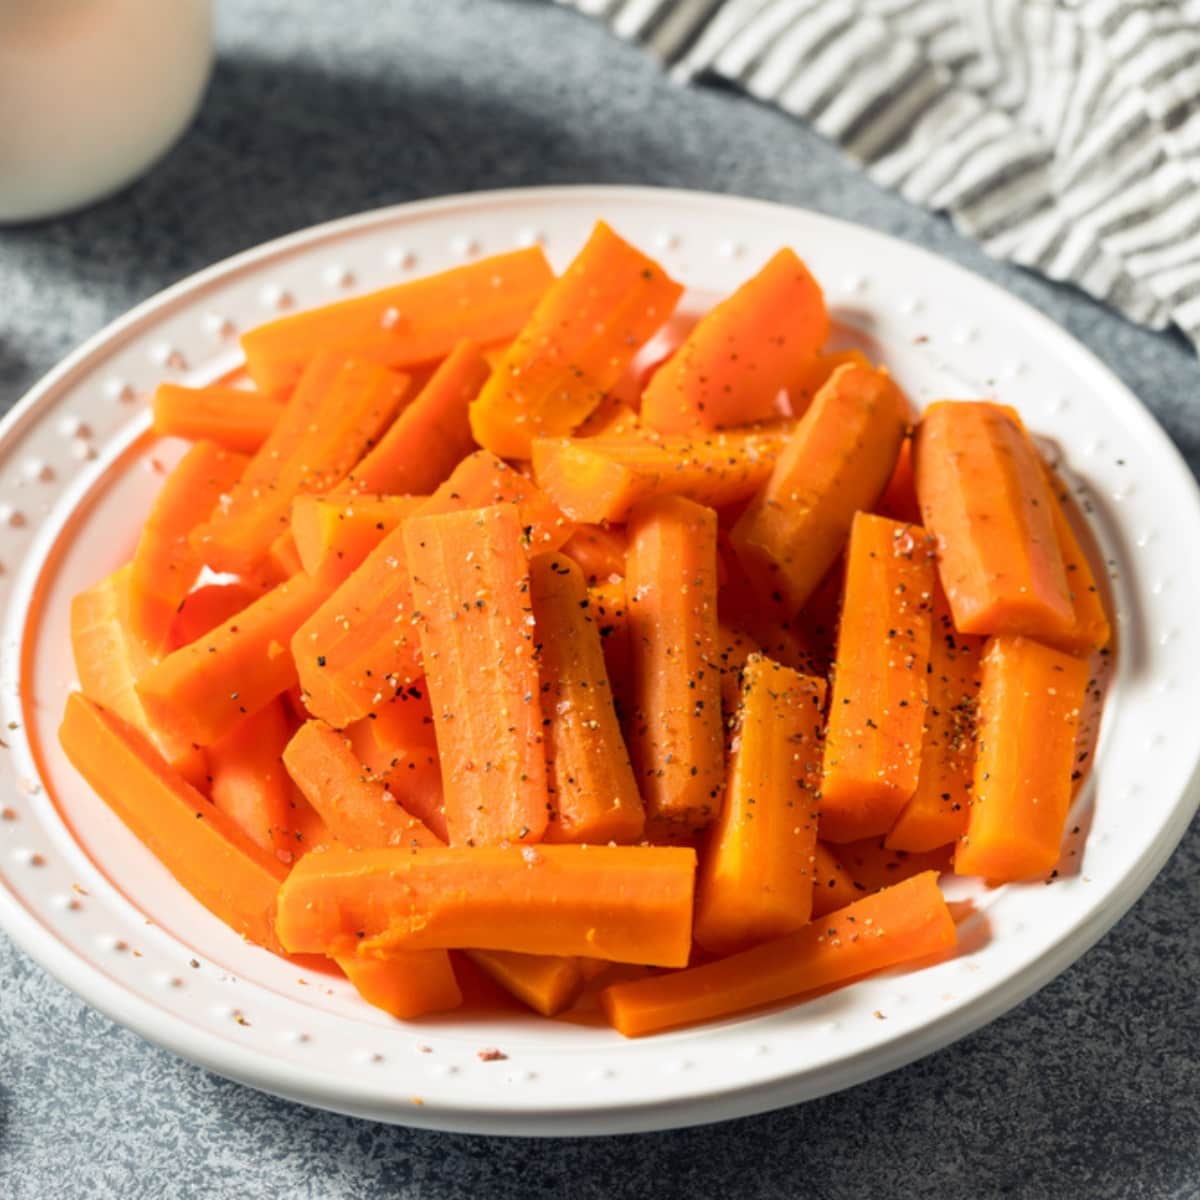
130;442;248;654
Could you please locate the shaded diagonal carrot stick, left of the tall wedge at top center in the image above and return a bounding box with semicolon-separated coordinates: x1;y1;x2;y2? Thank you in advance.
335;342;488;496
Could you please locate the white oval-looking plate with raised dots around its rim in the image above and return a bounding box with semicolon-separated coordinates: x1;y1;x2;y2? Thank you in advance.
0;187;1200;1134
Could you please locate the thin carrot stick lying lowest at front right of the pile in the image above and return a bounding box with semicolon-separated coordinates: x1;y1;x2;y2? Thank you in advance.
600;871;958;1038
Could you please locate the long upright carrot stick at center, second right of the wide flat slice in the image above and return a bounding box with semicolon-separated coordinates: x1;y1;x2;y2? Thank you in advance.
625;496;725;829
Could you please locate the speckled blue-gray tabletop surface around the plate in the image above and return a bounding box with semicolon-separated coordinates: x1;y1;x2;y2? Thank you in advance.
0;0;1200;1200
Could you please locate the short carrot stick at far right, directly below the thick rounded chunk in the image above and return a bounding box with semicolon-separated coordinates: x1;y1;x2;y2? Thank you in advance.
954;637;1087;883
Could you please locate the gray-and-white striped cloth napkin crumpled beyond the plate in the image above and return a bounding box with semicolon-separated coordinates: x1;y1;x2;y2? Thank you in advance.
558;0;1200;349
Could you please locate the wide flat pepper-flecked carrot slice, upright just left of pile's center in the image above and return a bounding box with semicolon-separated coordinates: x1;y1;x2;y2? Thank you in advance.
403;504;548;844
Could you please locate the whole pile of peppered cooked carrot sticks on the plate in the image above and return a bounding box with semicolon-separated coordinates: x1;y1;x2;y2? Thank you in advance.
61;223;1109;1036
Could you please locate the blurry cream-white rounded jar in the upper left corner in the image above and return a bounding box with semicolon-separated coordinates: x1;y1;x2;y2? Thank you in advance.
0;0;212;222
